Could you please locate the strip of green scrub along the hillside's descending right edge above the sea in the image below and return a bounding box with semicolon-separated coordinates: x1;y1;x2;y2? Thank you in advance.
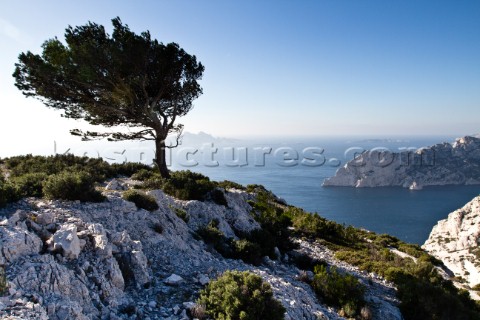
247;185;480;320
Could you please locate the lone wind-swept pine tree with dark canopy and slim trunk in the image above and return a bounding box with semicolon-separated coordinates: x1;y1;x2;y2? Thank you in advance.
13;17;204;177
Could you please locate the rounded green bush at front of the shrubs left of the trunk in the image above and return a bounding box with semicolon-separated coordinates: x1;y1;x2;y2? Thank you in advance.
43;171;105;202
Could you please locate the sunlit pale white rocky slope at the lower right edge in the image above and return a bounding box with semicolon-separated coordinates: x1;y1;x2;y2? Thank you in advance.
422;196;480;300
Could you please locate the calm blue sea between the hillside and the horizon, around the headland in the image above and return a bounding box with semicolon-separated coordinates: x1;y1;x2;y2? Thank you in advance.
171;137;480;244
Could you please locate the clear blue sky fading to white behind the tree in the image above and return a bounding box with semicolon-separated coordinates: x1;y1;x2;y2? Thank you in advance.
0;0;480;156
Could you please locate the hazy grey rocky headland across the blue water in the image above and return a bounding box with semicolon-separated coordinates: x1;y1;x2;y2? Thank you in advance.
323;136;480;190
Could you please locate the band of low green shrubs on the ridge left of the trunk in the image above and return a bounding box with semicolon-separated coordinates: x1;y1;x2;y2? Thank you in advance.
0;154;149;207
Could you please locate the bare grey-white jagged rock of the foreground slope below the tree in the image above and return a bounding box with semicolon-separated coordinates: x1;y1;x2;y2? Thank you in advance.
0;181;402;320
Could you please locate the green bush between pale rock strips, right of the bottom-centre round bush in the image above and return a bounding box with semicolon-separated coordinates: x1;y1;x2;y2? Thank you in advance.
312;265;365;317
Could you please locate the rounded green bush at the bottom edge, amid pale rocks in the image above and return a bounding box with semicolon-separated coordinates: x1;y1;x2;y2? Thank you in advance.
197;271;285;320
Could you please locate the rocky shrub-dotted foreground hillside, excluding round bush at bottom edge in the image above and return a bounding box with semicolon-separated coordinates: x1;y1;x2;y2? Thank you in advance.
0;156;479;319
